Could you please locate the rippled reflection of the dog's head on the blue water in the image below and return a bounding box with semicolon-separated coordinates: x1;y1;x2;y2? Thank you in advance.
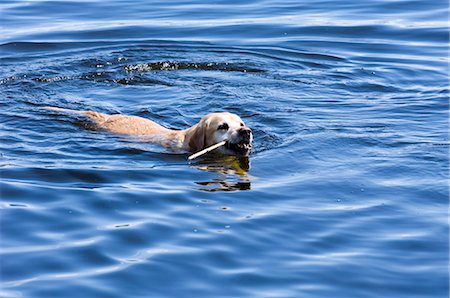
191;155;251;192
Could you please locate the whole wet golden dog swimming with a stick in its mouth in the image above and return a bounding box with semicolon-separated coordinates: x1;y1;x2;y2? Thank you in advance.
45;107;253;156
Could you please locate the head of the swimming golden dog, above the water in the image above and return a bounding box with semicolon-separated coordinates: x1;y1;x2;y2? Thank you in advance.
188;113;253;156
